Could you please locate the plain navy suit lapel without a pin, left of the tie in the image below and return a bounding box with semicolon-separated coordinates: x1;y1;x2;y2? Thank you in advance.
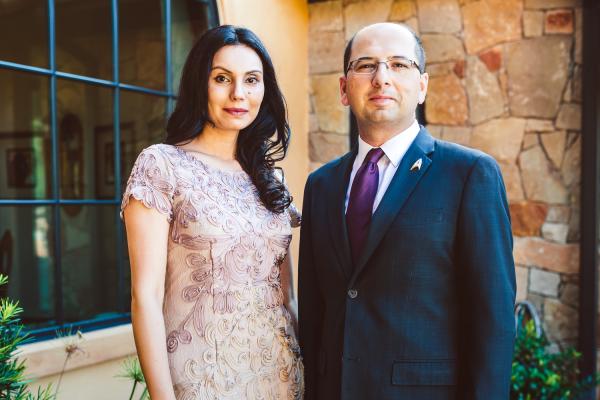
327;149;356;280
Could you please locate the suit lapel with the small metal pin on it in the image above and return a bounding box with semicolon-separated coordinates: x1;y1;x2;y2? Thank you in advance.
350;127;435;283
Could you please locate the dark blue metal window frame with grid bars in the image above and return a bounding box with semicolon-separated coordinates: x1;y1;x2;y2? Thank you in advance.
0;0;220;341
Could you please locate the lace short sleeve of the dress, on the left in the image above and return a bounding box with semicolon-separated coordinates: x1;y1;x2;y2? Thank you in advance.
121;145;175;223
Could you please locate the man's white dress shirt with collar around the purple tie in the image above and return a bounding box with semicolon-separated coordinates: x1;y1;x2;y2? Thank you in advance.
345;120;421;212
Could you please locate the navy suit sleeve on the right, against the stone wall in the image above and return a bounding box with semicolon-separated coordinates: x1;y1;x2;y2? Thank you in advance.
456;155;516;400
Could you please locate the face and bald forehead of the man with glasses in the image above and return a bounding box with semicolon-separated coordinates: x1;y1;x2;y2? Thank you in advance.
340;25;428;127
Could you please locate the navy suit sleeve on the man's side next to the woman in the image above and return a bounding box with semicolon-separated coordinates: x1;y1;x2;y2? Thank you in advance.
298;177;323;400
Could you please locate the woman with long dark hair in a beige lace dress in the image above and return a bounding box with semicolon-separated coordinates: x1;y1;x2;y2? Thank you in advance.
121;26;303;400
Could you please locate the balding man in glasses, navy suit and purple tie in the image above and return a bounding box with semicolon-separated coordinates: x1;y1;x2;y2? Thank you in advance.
299;23;515;400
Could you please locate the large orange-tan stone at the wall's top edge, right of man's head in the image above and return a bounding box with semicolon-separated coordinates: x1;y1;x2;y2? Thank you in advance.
462;0;523;54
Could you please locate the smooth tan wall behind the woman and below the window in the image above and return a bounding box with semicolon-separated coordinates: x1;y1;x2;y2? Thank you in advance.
23;0;308;400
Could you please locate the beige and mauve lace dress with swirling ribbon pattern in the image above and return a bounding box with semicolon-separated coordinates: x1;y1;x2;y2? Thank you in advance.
121;144;303;400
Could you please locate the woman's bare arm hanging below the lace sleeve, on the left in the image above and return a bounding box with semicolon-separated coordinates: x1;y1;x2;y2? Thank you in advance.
124;197;175;400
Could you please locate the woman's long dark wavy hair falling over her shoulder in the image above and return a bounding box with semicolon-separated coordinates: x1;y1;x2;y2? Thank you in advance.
165;25;292;213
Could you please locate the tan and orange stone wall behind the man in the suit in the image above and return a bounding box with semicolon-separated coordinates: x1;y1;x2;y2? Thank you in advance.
309;0;582;343
